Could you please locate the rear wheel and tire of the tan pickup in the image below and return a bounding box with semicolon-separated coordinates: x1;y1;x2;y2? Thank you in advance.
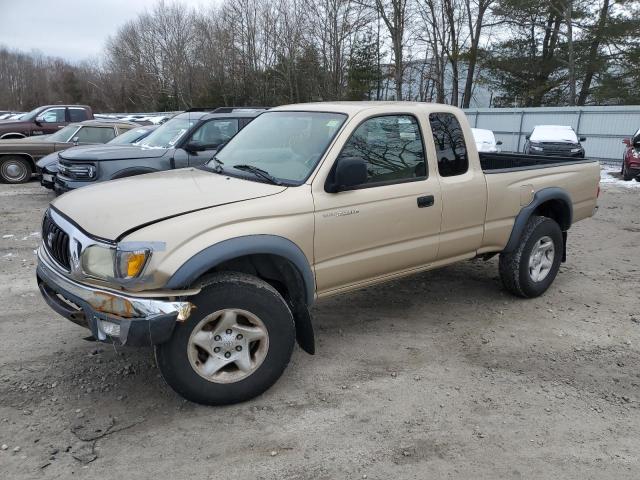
499;216;564;298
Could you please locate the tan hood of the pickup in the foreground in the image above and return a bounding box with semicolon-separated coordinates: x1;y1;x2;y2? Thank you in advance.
51;168;286;241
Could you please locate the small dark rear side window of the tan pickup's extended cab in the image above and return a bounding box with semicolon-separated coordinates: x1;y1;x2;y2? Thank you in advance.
429;113;469;177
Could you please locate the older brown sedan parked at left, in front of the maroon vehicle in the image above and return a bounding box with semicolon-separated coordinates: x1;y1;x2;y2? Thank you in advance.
0;120;137;183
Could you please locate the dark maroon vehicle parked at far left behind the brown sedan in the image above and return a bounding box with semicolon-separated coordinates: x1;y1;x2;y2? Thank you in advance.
0;105;93;139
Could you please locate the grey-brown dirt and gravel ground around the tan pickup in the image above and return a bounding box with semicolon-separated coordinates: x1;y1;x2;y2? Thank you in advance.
0;176;640;480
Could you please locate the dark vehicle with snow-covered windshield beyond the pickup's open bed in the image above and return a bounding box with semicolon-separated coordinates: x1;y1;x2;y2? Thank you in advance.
524;125;587;158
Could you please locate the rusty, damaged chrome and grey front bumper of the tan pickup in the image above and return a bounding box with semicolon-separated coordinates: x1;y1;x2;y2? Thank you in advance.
36;248;193;346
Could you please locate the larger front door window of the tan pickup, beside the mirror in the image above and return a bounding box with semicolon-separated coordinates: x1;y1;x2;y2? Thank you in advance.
340;115;427;184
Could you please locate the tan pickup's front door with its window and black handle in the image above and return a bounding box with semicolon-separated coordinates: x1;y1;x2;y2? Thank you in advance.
312;115;442;295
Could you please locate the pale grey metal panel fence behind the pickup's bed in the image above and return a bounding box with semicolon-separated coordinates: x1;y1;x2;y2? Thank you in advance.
465;106;640;163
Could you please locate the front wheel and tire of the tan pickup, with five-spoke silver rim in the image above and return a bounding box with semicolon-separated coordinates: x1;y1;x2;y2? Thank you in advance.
156;272;295;405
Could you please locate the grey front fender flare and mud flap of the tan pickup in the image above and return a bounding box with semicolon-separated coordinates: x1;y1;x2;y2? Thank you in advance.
165;235;315;354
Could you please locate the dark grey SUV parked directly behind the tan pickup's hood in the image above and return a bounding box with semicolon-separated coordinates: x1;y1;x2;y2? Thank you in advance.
54;107;265;193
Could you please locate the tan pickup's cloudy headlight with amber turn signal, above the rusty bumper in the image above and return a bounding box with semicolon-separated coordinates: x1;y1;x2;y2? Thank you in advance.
82;245;151;280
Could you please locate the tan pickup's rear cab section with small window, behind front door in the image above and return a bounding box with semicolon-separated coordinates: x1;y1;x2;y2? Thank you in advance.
429;112;487;260
